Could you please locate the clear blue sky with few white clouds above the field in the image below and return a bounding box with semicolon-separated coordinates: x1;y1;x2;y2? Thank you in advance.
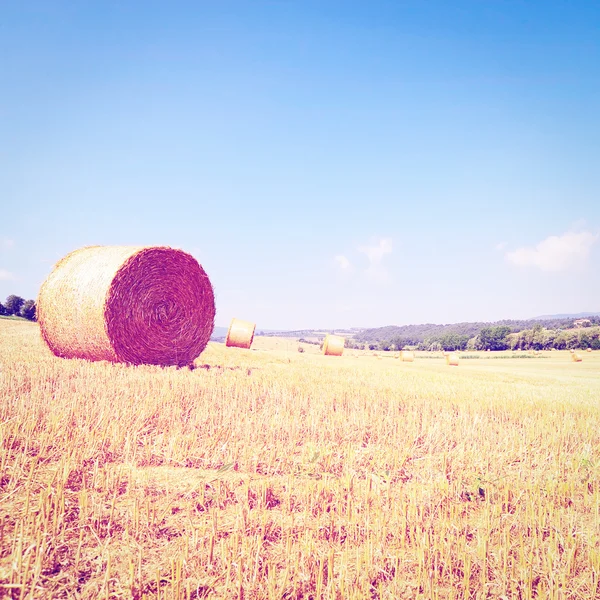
0;0;600;329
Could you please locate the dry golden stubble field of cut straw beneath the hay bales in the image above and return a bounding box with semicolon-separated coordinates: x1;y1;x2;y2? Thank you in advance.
0;320;600;600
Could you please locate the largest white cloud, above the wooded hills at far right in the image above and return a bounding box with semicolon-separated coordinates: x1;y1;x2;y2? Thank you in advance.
505;231;600;272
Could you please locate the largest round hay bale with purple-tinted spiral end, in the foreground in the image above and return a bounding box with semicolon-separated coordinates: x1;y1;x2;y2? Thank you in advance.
37;246;215;366
